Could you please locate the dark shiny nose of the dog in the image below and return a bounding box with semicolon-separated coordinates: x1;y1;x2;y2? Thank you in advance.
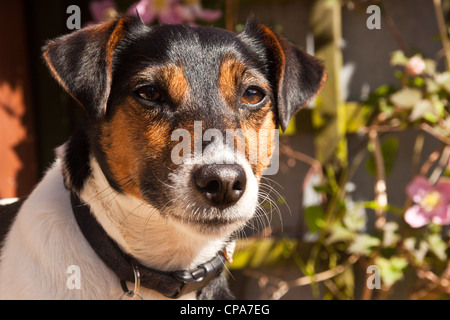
194;164;247;208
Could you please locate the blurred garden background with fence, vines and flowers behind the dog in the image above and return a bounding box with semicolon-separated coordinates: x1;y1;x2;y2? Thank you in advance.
0;0;450;299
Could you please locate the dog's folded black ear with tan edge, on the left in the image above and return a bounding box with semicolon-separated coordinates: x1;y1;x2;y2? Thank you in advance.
43;18;141;120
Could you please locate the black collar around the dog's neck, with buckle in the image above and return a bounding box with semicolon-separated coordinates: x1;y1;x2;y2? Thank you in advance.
70;192;229;299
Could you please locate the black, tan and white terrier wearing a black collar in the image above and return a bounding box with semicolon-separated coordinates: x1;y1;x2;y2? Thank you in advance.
0;17;326;299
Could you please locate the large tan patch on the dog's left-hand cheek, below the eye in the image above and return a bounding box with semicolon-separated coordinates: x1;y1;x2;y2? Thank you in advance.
100;98;170;199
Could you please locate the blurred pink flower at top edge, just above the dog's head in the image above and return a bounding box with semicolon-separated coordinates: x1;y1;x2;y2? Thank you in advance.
128;0;183;24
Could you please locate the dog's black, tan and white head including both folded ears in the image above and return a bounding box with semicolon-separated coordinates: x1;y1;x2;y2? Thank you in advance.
44;18;325;234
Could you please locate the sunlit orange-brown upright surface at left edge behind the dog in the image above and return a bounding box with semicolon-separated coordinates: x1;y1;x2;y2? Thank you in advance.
0;0;38;198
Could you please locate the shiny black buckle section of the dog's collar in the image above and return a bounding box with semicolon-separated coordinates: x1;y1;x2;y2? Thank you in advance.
170;251;226;299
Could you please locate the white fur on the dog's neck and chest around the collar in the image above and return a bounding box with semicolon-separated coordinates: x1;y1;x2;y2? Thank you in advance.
0;160;229;299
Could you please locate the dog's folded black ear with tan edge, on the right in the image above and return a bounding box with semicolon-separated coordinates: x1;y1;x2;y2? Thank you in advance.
239;17;327;131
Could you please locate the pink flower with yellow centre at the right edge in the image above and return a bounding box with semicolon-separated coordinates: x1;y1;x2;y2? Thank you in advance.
404;176;450;228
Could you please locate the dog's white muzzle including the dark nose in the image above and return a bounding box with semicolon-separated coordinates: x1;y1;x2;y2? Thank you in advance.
165;146;258;235
